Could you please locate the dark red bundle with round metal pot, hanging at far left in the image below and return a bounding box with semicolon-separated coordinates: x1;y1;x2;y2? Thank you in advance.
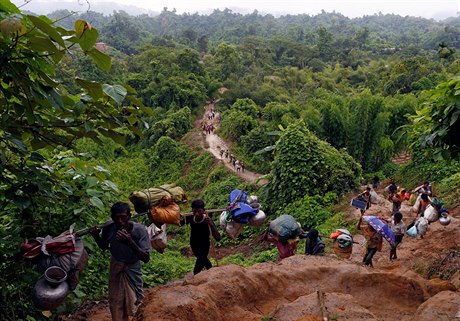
21;224;88;310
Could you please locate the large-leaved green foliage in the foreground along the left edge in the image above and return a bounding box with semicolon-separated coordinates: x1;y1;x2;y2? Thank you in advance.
0;0;144;320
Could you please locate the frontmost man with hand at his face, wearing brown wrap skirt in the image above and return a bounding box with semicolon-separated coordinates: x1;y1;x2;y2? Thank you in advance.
90;202;151;321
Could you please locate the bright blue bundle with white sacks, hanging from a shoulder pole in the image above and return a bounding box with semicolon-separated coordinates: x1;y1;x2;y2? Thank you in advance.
220;189;265;239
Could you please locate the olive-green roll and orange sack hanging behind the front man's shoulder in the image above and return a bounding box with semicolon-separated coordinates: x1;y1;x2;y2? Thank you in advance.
129;184;187;253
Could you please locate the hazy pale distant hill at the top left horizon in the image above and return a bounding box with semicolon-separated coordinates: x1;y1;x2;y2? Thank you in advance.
12;0;159;16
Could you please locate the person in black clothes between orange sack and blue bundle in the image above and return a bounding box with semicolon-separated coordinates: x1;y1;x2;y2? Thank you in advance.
181;200;221;274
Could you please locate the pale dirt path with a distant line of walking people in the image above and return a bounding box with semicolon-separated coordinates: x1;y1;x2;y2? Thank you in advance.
200;103;267;186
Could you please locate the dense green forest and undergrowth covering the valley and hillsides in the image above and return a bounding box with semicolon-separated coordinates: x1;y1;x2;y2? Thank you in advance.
0;0;460;321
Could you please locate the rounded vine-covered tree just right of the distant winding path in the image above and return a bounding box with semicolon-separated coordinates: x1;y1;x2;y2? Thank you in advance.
267;121;361;210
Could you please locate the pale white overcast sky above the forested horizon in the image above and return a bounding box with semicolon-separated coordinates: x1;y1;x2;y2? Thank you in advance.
12;0;460;19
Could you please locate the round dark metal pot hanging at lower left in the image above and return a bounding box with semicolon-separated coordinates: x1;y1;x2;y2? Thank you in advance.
32;266;70;310
